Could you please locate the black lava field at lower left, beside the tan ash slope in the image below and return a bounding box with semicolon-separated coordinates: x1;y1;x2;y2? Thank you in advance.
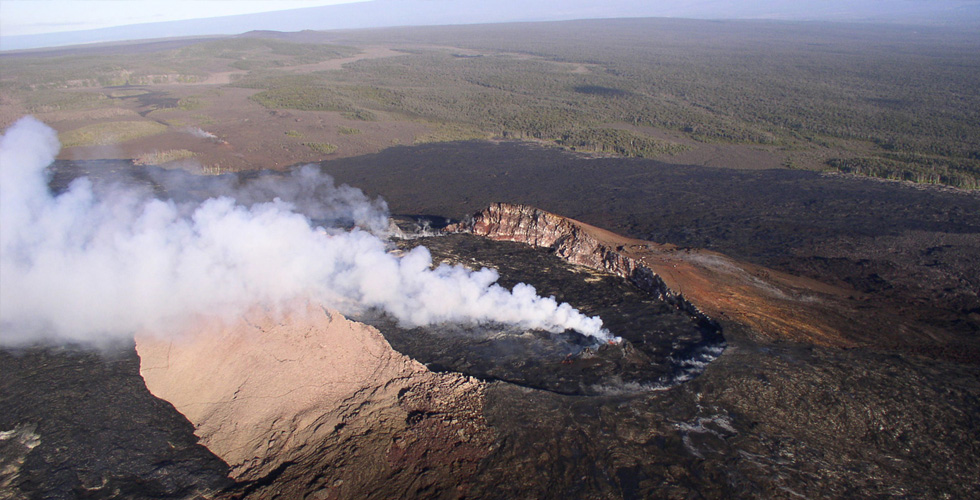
0;346;231;499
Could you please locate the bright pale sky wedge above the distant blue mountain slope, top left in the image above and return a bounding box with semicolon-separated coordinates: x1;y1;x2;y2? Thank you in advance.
0;0;364;36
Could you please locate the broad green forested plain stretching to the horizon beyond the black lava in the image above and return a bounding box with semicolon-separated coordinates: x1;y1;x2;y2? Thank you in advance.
0;19;980;189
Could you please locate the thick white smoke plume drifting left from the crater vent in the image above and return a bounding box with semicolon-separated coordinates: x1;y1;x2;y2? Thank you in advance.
0;117;610;344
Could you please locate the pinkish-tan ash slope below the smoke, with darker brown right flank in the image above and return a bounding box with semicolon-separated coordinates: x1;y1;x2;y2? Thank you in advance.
136;303;492;498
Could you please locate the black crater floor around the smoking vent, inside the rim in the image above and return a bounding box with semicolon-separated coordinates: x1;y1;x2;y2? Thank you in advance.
368;225;725;395
